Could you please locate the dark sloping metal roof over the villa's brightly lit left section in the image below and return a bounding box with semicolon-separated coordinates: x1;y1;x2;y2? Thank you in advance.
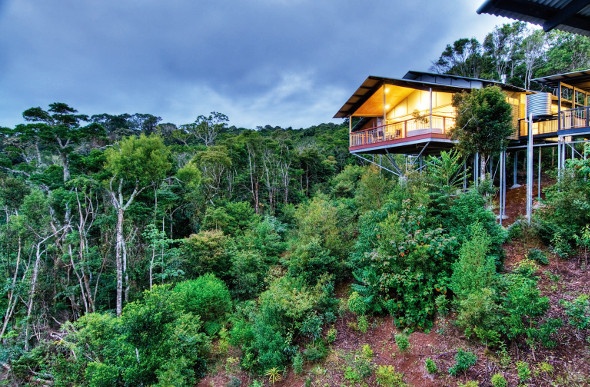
334;71;525;118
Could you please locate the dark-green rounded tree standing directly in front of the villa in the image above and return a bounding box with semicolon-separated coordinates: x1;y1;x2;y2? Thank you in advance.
451;86;514;179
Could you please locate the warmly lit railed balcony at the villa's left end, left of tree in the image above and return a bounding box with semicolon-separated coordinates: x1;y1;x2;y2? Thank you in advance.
350;115;455;151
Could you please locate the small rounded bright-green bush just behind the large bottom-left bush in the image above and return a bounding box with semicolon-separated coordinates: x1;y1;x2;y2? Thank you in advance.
174;274;232;336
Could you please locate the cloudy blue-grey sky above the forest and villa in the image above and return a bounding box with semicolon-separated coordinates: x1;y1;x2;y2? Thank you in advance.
0;0;509;128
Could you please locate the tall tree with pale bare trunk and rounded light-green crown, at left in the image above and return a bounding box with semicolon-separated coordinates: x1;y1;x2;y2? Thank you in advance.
105;134;172;316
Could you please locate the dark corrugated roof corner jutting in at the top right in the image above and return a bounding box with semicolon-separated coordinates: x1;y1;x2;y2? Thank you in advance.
477;0;590;36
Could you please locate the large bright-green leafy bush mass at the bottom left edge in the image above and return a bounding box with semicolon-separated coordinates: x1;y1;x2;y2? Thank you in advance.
52;286;209;386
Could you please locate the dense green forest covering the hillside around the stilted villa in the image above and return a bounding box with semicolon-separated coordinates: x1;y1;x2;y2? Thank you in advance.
0;23;590;386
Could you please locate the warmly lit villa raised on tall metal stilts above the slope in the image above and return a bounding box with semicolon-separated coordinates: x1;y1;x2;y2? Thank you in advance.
334;70;590;220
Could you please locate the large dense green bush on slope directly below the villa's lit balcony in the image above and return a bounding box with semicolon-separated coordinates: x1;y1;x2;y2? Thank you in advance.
352;199;455;327
